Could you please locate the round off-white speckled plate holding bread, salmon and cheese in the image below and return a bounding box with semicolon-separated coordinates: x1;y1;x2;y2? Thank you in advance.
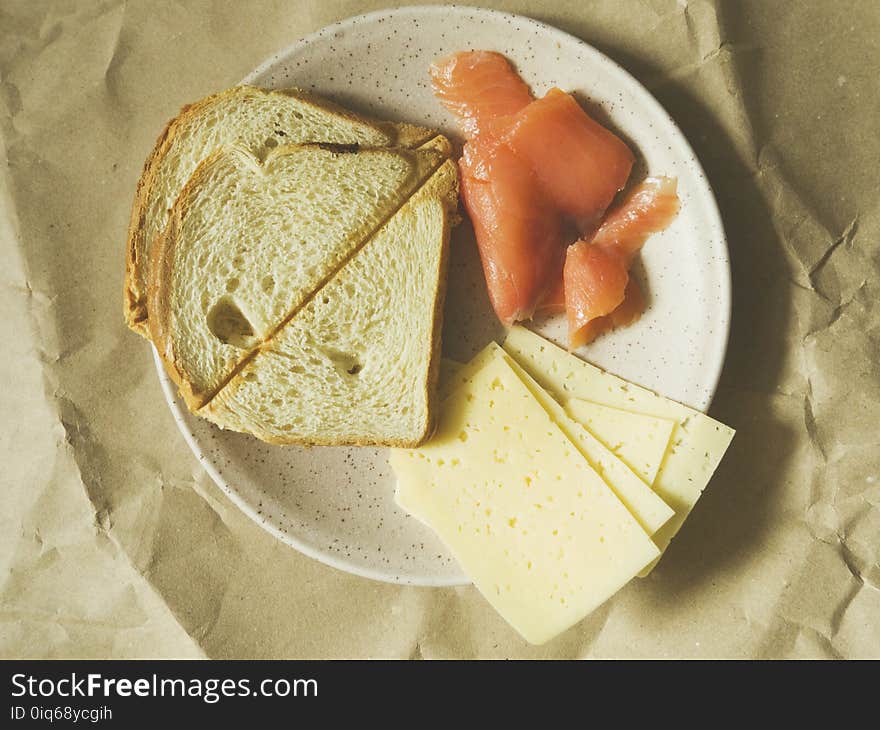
157;6;730;586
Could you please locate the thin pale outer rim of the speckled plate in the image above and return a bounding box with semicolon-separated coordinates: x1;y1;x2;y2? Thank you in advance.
151;4;733;588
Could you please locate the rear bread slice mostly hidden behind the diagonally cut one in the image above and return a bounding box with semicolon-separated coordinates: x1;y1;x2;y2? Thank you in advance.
124;86;435;335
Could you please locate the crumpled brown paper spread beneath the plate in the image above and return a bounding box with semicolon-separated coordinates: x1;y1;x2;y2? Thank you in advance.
0;0;880;658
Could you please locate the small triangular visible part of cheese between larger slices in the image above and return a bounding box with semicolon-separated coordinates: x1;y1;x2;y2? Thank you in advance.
563;398;675;485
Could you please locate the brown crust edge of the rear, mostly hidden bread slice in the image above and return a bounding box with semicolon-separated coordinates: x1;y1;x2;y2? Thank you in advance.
123;86;438;338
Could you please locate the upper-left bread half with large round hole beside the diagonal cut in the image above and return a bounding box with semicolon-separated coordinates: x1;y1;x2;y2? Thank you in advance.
148;145;444;410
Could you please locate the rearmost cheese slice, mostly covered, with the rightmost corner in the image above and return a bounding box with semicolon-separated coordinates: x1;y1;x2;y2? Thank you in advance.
504;327;734;549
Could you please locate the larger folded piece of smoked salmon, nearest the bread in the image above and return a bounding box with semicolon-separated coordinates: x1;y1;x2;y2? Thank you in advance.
431;51;633;324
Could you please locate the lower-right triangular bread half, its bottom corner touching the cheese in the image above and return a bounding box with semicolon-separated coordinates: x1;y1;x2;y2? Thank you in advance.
199;160;458;447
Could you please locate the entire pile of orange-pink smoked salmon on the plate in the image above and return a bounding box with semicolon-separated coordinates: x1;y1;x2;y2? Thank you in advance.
430;51;678;346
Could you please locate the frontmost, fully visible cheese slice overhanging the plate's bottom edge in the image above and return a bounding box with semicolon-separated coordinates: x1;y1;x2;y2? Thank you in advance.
391;357;659;644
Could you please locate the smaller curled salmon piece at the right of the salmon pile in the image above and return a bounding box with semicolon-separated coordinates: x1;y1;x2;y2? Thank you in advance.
563;177;679;348
